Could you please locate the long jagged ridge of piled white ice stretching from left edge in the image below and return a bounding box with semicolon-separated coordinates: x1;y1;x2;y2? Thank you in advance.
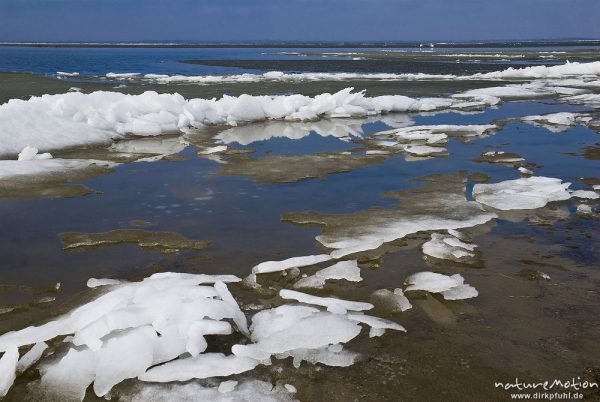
0;88;496;155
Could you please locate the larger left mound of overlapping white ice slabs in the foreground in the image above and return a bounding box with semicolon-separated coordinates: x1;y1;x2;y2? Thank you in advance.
0;274;247;399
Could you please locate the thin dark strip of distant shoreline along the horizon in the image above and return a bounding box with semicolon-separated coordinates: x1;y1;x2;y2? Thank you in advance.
0;39;600;49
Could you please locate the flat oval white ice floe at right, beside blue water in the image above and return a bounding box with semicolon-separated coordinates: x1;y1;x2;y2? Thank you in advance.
473;176;571;210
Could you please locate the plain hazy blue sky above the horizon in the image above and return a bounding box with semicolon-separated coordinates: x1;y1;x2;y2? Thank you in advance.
0;0;600;42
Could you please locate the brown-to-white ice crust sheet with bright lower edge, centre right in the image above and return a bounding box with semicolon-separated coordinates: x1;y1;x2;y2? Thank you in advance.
284;175;497;258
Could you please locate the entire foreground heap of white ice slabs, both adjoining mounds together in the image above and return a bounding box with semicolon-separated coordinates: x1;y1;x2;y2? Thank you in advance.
0;272;404;400
